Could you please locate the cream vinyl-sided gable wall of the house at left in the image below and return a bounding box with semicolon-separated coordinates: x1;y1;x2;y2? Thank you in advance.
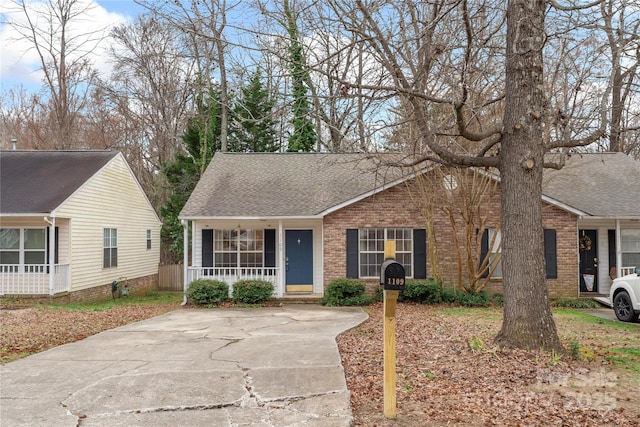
55;154;161;291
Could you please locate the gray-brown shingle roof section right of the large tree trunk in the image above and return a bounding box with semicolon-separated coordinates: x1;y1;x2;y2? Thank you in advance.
542;153;640;218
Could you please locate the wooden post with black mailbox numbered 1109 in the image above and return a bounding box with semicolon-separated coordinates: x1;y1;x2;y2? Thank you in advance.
380;241;405;418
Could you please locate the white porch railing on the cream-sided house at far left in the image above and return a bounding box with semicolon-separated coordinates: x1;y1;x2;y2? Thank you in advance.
0;264;71;295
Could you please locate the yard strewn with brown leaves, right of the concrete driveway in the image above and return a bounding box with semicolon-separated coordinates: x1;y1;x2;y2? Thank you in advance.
338;304;640;427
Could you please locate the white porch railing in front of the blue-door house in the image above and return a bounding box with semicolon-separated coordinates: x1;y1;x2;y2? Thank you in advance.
187;267;280;297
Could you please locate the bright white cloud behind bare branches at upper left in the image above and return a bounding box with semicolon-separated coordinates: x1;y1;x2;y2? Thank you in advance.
0;0;132;90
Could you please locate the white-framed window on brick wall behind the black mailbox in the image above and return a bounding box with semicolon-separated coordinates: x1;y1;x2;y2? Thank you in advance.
358;228;413;277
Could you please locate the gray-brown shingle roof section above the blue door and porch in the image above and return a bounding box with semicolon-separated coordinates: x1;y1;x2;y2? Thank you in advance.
180;153;410;218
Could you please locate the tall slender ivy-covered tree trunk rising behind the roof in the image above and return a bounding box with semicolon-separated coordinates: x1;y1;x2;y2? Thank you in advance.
284;0;316;152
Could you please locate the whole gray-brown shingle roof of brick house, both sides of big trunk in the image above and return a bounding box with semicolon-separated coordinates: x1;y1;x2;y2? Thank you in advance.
180;153;640;218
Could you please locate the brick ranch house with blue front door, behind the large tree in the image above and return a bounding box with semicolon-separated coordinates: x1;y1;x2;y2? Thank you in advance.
180;153;640;298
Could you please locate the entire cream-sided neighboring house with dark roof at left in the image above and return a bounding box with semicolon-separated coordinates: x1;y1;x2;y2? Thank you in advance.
0;150;161;299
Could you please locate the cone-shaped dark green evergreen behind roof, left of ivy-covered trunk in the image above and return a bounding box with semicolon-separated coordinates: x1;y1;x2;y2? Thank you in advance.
229;68;280;152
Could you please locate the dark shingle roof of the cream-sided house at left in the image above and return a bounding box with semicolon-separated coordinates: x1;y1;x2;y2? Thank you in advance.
0;150;118;214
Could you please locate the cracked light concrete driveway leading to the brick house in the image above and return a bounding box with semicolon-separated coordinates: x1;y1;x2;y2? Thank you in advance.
0;305;367;427
